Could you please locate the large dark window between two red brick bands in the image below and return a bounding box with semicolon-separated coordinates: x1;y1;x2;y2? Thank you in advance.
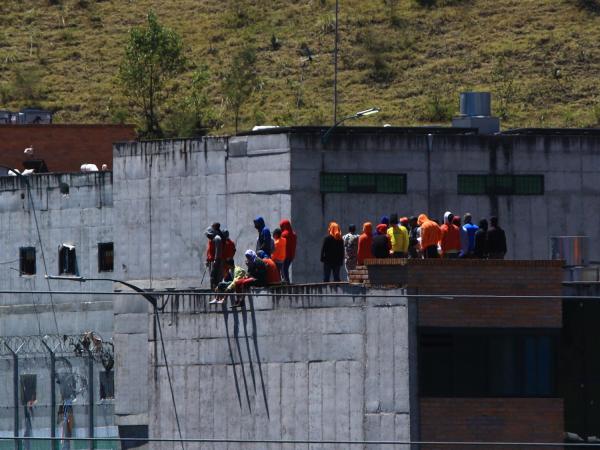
419;329;558;397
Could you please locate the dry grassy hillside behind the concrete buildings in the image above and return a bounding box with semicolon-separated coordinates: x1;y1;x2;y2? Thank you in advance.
0;0;600;133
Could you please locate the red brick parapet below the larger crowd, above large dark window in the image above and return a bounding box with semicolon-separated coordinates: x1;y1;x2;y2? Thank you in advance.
352;259;563;328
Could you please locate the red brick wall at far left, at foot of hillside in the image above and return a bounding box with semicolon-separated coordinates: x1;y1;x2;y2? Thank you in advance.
0;125;136;172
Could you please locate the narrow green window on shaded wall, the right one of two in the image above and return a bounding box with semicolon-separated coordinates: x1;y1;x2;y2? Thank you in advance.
458;175;544;195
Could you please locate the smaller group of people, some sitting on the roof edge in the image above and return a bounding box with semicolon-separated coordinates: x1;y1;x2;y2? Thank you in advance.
205;217;297;306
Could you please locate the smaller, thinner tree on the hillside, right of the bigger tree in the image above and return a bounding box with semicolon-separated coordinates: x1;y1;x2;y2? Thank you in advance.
223;47;258;133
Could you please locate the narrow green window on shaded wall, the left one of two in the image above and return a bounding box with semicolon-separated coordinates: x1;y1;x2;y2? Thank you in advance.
321;172;406;194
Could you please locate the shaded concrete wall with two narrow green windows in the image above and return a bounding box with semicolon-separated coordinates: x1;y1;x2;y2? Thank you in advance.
290;130;600;279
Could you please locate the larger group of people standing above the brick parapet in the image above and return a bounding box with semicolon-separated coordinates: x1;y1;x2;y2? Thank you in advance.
321;211;507;282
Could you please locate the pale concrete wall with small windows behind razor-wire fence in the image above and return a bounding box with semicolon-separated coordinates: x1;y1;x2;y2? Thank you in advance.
0;172;116;442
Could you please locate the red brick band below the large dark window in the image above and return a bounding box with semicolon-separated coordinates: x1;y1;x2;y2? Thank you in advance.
420;398;564;450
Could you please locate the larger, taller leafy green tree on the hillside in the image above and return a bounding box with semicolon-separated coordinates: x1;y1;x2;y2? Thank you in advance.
119;12;186;137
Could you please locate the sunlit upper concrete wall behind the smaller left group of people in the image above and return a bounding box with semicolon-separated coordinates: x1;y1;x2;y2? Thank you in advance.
114;135;291;287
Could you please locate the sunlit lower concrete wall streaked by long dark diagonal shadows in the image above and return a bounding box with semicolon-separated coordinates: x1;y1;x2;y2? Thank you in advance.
143;285;412;449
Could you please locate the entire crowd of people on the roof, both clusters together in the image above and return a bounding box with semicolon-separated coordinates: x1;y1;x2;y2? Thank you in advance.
205;211;507;303
